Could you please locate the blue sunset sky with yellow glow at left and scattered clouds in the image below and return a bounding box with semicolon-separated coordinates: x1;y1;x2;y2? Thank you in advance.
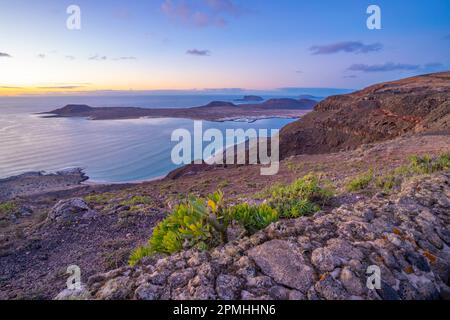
0;0;450;95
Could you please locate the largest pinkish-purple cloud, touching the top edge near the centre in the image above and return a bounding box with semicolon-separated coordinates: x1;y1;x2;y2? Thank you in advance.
161;0;244;27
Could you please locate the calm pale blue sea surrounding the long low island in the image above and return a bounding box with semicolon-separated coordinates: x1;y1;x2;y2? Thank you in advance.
0;96;298;182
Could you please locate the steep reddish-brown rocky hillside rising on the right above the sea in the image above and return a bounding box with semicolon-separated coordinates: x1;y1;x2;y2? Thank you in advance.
280;72;450;157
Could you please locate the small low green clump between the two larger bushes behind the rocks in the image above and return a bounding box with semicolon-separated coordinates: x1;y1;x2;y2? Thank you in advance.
228;203;279;233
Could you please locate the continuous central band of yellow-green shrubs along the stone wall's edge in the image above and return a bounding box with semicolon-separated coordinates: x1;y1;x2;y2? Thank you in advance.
129;175;332;265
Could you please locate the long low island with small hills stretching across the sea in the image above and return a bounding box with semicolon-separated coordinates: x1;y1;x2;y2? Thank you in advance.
40;99;317;122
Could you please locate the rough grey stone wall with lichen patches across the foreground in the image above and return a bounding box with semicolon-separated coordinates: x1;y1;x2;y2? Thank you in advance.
57;173;450;300
